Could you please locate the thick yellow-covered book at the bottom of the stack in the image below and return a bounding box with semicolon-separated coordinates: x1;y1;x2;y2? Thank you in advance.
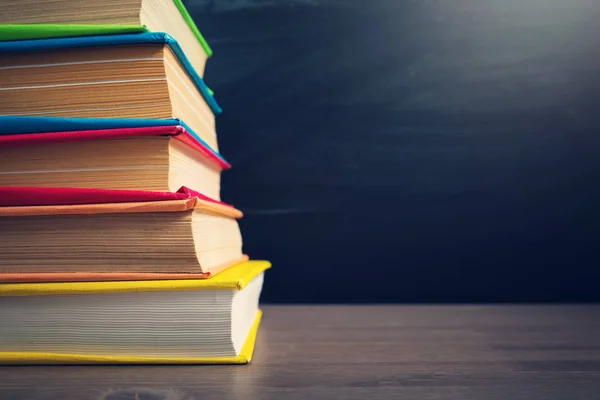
0;261;271;364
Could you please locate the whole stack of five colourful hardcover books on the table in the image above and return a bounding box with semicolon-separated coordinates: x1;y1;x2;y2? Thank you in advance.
0;0;270;364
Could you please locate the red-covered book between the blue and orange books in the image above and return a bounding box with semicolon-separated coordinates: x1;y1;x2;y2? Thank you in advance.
0;116;231;200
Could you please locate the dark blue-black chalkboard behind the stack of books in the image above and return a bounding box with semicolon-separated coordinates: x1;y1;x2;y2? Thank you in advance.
185;0;600;303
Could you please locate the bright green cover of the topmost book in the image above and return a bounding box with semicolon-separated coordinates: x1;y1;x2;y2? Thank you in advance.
0;0;213;57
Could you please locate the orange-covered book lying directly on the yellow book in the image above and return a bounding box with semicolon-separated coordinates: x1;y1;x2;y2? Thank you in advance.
0;187;246;282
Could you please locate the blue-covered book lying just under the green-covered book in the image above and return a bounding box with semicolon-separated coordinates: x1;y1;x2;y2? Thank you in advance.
0;33;222;151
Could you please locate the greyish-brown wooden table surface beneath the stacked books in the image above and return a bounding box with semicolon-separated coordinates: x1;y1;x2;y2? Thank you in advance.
0;306;600;400
